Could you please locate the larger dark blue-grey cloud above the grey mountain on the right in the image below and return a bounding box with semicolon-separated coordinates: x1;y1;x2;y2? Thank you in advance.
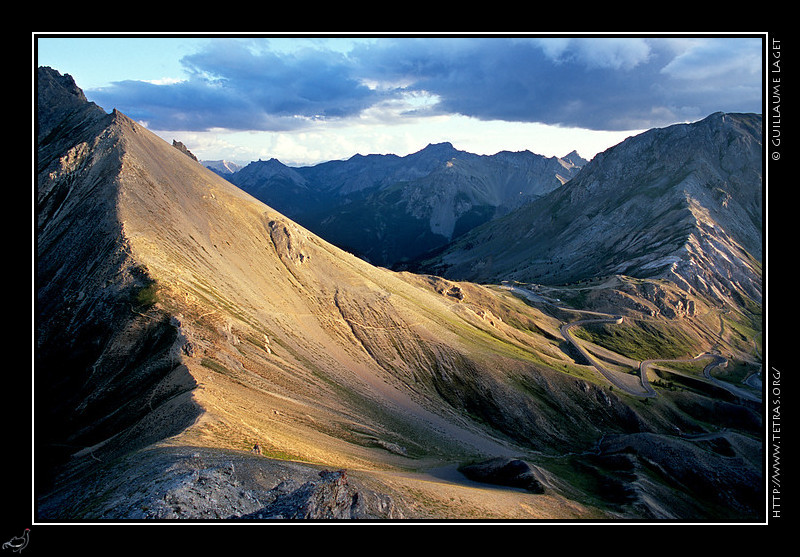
350;38;761;130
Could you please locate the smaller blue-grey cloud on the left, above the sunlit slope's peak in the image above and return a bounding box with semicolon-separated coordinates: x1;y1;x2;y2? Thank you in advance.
90;39;378;131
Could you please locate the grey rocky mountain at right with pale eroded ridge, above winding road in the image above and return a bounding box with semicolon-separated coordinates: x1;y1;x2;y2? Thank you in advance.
423;113;763;296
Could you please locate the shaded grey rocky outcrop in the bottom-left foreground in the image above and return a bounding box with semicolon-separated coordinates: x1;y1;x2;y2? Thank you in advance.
40;448;406;521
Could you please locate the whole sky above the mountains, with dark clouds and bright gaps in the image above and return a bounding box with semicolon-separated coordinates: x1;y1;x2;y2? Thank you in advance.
34;35;764;164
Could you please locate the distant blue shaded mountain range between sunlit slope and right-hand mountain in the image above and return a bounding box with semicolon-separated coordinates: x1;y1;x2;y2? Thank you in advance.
227;143;586;267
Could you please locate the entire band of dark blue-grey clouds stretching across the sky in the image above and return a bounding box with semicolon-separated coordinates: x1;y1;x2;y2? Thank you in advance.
86;37;761;130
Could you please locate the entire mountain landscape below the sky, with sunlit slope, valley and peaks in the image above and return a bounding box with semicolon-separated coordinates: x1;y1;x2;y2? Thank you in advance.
33;68;765;522
